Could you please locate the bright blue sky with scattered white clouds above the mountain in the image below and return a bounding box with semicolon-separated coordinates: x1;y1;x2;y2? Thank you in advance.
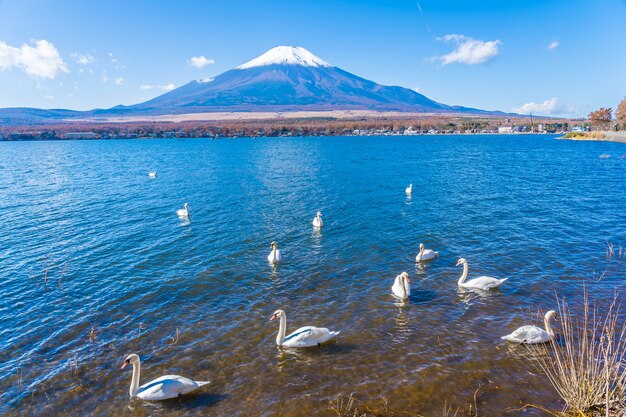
0;0;626;116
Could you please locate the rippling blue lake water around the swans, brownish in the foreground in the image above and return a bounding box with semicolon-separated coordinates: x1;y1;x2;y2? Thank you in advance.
0;135;626;416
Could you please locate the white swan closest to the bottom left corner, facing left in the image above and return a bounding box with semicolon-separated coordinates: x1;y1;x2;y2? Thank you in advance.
122;353;210;401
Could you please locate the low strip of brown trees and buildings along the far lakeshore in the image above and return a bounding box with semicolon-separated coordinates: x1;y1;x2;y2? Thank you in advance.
0;116;576;140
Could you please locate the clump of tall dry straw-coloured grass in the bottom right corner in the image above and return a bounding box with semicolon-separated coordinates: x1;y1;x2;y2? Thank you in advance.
528;289;626;417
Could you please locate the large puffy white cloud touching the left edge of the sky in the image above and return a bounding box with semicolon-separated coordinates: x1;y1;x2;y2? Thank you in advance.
0;40;70;79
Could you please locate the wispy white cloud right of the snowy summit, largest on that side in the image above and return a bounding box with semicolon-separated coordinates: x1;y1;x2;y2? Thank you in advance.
431;34;502;65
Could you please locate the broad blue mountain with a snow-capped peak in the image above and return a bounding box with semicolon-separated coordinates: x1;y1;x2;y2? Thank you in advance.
0;46;505;124
